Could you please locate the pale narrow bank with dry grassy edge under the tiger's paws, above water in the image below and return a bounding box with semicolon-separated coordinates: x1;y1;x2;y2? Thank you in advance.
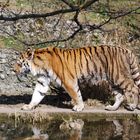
0;104;140;123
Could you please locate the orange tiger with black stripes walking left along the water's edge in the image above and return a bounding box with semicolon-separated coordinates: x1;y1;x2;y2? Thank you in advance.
14;45;140;112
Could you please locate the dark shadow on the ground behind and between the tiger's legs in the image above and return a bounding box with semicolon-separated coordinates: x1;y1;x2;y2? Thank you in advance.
0;84;110;108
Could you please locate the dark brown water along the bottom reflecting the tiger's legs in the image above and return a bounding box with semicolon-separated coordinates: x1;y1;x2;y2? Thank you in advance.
0;118;140;140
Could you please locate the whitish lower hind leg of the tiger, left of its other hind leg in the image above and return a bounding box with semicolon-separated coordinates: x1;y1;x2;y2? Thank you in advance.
105;91;124;111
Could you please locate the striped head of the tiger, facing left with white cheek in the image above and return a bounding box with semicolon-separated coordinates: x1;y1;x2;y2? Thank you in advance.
14;48;33;75
